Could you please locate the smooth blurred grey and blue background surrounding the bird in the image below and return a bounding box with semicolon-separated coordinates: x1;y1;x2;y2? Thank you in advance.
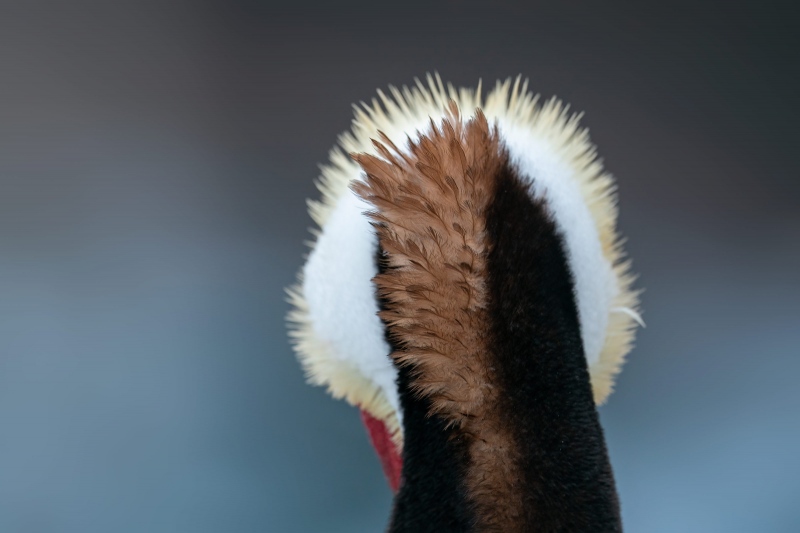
0;0;800;533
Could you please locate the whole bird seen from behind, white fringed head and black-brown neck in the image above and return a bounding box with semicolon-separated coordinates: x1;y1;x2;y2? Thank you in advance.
290;76;639;533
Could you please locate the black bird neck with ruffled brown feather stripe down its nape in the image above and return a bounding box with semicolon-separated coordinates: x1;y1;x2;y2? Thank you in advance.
354;112;621;533
